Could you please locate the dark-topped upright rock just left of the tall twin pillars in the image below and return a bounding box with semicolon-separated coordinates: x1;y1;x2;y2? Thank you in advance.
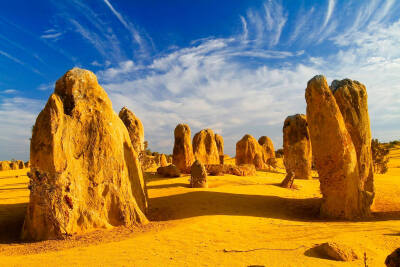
283;114;312;179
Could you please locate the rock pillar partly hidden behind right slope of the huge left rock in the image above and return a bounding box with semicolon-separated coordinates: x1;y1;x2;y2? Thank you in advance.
119;107;144;154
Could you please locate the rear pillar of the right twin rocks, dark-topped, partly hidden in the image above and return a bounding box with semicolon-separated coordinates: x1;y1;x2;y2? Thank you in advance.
330;79;375;202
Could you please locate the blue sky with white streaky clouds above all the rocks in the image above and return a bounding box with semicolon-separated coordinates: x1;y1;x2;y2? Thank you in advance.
0;0;400;160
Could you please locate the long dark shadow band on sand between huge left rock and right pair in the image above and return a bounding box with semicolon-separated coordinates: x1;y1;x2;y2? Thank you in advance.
149;191;321;221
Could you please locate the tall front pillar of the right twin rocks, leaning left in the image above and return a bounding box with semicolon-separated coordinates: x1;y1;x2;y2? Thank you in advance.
305;75;370;219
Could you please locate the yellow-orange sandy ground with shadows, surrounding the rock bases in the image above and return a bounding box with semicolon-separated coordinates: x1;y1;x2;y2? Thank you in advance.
0;149;400;266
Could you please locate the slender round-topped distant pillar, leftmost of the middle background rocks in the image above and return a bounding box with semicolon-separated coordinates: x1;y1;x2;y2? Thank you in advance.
172;124;194;173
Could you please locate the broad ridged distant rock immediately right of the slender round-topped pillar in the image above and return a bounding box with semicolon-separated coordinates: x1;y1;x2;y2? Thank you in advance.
192;129;220;164
